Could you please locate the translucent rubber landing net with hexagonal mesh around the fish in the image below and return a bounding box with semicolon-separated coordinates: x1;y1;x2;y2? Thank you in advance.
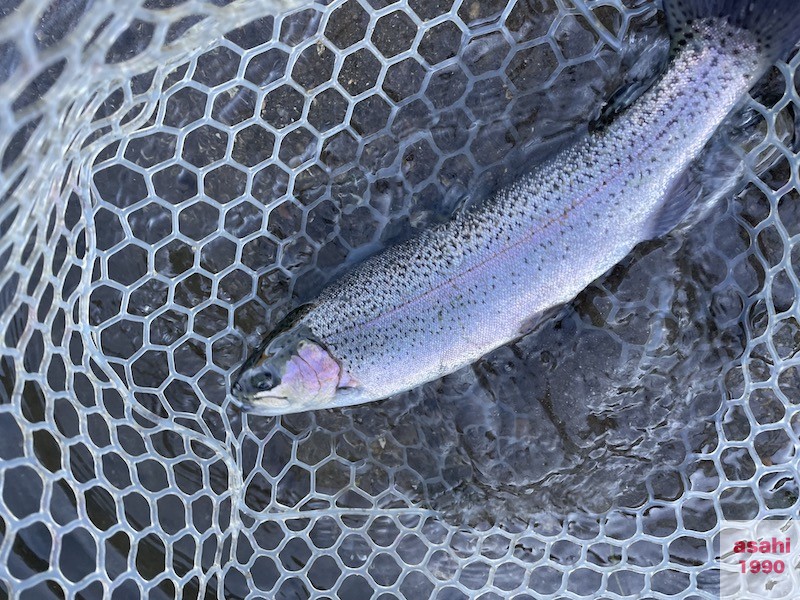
0;0;800;600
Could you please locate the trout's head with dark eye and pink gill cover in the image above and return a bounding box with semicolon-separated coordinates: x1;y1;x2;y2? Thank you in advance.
233;330;356;416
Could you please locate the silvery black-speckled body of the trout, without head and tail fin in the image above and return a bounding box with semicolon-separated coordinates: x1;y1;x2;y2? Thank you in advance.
304;21;761;399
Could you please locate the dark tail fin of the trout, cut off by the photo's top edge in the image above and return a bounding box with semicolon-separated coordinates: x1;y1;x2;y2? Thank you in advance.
664;0;800;64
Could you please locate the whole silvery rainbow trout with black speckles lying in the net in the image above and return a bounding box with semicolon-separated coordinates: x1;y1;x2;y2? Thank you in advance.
233;0;800;415
